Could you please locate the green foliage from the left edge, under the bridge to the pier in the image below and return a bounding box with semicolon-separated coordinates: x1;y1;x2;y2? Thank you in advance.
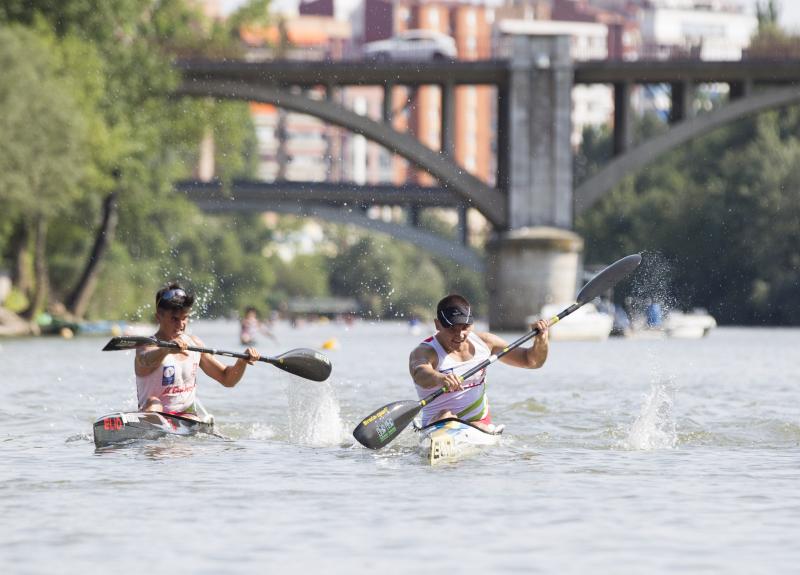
0;0;485;321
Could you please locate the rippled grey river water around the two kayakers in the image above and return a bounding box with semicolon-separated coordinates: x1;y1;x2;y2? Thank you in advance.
0;322;800;574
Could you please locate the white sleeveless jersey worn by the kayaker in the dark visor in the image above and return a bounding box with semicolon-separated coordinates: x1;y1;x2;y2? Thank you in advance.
416;332;492;426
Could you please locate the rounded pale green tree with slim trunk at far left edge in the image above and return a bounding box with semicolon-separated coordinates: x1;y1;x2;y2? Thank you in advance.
0;27;87;317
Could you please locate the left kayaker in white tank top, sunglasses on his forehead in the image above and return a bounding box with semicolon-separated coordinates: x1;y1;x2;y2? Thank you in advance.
134;283;259;414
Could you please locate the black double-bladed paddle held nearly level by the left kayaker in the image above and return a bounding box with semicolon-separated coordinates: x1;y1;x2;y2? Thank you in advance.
103;336;331;381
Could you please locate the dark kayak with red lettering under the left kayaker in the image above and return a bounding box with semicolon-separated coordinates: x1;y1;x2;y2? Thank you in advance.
94;411;214;447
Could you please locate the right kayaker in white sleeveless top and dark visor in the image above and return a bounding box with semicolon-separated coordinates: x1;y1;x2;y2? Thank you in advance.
409;294;549;431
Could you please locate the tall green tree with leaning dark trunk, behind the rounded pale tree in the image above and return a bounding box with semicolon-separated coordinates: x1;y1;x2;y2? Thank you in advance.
0;0;266;316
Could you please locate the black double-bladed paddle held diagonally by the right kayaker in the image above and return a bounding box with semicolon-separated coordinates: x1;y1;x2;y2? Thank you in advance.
353;254;642;449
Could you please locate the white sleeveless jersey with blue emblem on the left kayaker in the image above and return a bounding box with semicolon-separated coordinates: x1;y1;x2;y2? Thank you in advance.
136;335;200;413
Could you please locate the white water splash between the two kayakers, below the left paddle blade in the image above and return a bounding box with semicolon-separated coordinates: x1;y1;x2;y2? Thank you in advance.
286;381;344;447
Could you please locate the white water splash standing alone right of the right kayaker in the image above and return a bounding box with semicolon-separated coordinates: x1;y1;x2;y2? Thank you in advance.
623;383;678;450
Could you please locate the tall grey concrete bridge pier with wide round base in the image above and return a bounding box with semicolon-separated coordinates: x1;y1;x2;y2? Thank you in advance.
486;35;583;330
